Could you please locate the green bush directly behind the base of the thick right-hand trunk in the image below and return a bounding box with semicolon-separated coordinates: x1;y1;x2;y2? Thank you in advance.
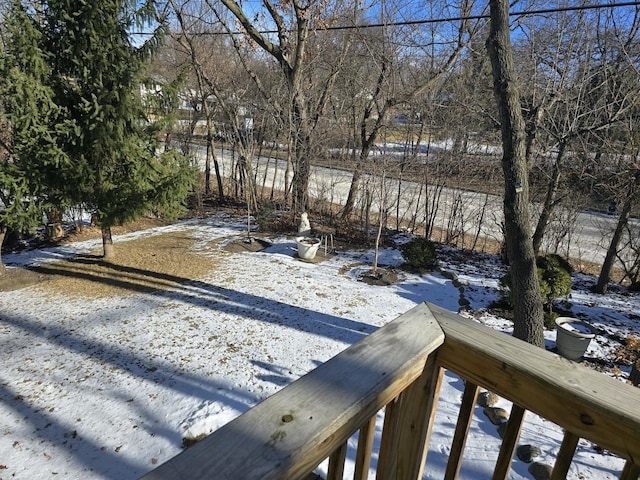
500;254;573;311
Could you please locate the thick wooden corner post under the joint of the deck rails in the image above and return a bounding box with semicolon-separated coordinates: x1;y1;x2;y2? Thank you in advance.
377;357;443;480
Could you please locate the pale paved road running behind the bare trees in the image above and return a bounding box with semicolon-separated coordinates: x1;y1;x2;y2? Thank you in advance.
194;146;615;263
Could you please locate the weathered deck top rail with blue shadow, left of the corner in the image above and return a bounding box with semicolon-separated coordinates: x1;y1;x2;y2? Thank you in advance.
143;304;444;480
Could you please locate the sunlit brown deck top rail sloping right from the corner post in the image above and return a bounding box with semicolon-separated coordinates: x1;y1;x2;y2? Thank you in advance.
430;305;640;463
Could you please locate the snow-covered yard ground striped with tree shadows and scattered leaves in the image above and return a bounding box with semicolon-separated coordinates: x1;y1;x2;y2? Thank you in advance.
0;216;640;480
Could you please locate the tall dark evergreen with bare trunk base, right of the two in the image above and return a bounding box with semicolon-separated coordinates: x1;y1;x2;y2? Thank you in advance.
0;0;195;259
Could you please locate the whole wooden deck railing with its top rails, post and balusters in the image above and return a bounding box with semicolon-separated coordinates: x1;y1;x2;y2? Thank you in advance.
143;303;640;480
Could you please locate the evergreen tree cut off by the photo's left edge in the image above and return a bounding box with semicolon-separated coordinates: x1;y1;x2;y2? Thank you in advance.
0;1;70;274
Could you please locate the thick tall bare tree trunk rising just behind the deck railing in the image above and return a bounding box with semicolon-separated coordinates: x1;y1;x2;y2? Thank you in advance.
486;0;544;347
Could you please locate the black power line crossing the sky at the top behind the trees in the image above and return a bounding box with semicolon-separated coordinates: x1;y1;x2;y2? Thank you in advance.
140;1;640;36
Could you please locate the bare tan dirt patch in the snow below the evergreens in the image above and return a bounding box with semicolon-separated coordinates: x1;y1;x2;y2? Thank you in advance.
26;232;217;297
